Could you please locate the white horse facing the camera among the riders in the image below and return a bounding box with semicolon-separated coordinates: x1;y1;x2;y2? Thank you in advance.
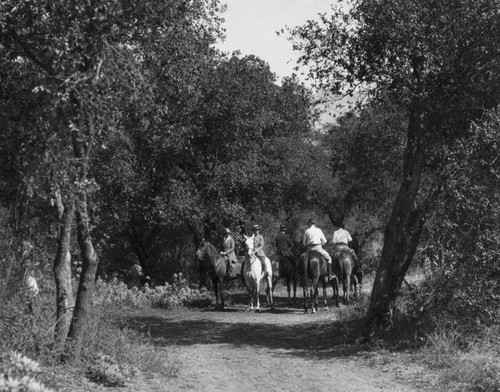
243;235;274;311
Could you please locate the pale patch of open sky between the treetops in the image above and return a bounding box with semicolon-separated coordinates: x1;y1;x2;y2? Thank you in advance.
218;0;337;80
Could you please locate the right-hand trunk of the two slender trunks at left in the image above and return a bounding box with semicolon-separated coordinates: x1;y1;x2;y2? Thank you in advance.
68;191;98;361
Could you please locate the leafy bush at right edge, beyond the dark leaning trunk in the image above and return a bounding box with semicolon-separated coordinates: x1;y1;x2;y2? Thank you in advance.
424;110;500;324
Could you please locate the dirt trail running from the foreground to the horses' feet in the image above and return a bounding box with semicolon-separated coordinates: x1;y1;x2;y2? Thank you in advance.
125;288;422;392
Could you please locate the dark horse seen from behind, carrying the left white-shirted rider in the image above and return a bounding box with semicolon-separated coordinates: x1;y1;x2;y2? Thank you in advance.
300;251;328;313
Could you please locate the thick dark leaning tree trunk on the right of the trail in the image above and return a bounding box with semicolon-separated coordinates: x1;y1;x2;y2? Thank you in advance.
367;103;425;336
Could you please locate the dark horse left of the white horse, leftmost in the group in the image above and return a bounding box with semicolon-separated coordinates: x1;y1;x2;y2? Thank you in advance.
196;241;239;310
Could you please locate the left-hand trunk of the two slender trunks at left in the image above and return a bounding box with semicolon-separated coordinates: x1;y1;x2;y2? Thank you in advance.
54;194;75;344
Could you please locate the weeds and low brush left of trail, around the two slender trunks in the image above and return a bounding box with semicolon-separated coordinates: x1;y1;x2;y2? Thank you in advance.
0;274;212;392
